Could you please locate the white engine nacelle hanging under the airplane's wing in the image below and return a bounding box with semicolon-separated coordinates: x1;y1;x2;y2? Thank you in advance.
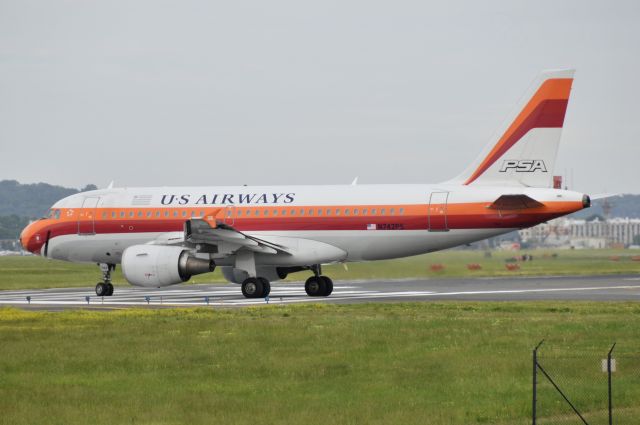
121;245;216;287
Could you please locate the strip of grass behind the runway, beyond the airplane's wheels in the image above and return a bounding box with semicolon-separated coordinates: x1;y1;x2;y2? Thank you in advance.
0;250;640;290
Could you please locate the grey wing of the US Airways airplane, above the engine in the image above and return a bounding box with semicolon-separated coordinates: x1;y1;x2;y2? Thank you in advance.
184;219;290;254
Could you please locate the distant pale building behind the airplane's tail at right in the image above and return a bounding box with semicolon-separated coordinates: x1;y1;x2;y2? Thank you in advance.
518;218;640;248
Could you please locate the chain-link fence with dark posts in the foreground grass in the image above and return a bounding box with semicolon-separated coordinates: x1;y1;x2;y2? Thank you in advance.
532;343;640;425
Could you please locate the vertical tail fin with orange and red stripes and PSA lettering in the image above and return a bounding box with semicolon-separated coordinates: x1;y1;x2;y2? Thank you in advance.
454;69;574;187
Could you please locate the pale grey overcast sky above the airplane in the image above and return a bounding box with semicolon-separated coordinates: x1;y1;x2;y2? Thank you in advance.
0;0;640;193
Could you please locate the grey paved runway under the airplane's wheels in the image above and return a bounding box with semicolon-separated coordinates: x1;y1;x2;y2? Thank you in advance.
0;275;640;310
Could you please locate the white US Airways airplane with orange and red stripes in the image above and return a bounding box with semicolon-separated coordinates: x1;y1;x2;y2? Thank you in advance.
20;69;591;298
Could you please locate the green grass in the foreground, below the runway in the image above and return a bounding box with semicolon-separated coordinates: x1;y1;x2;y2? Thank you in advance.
0;302;640;424
